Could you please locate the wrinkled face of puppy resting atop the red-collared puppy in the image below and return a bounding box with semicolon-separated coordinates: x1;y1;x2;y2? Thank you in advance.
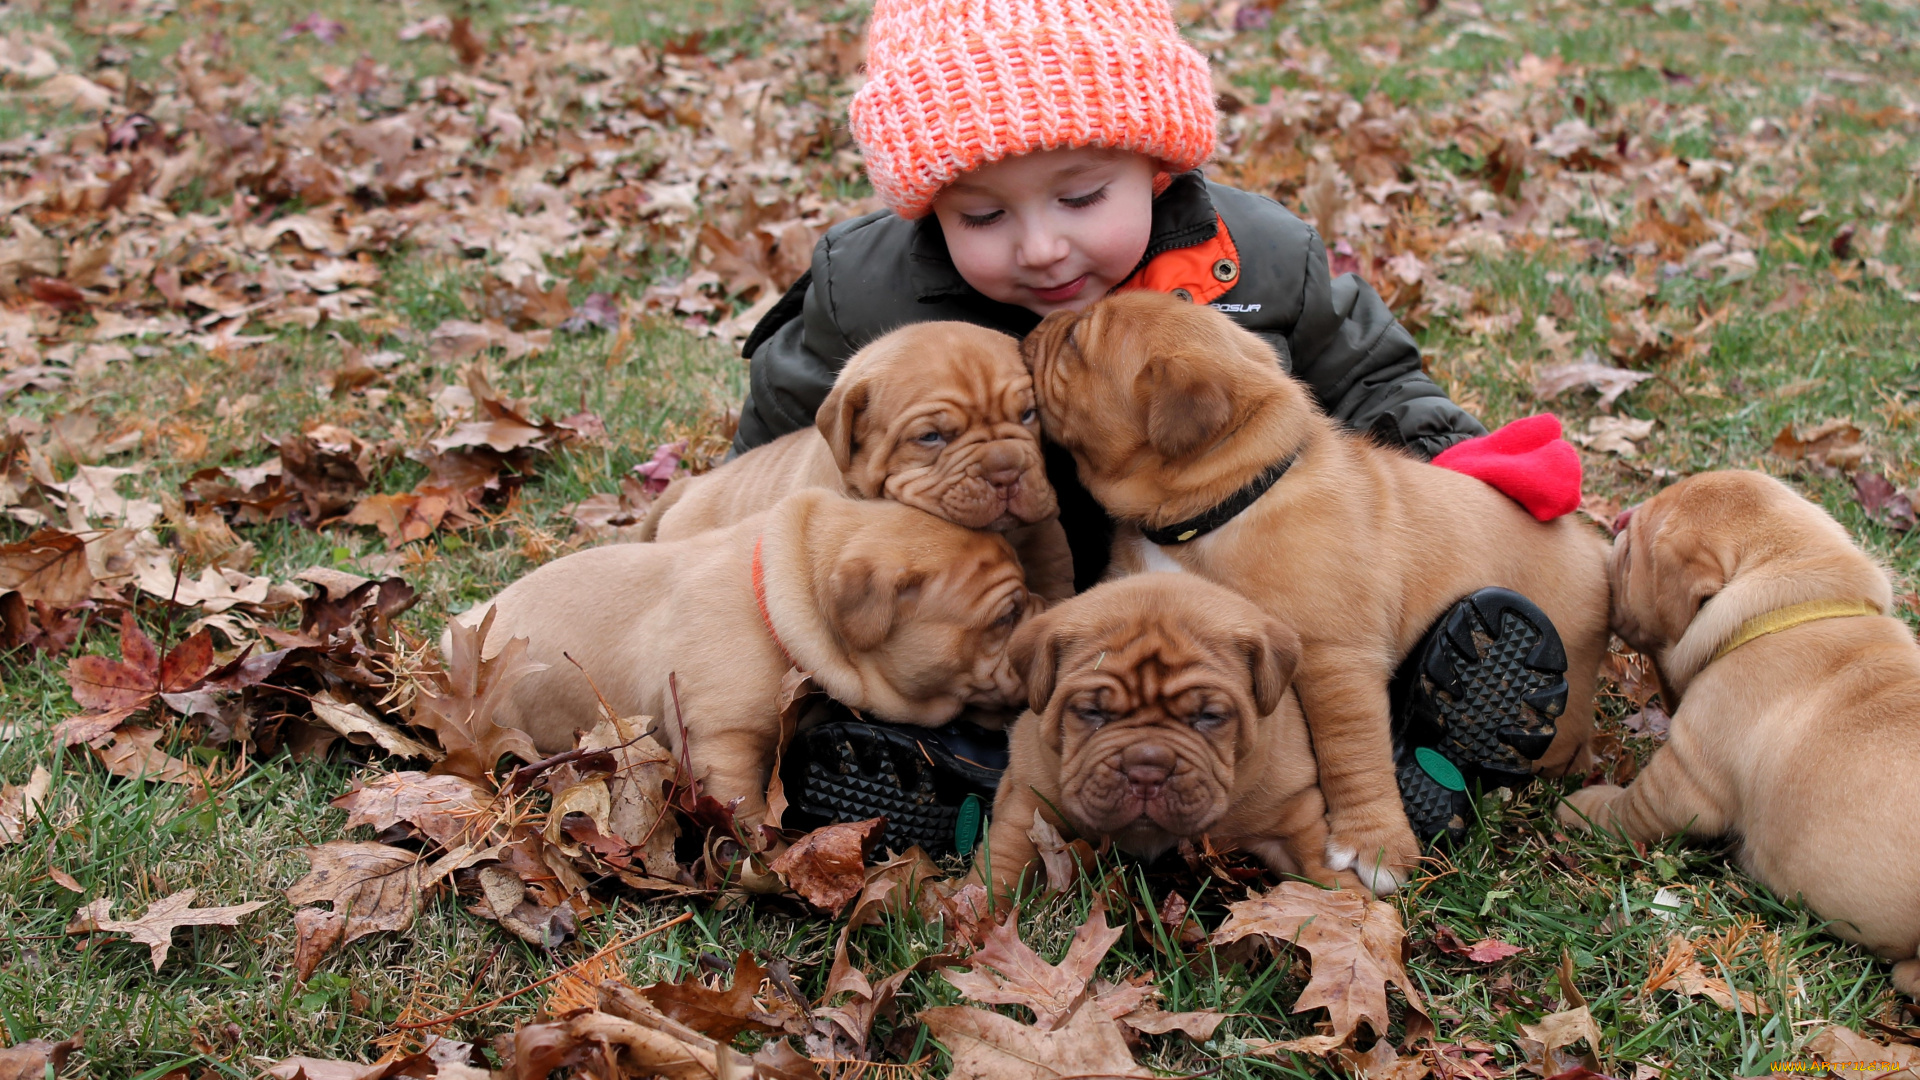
814;323;1058;532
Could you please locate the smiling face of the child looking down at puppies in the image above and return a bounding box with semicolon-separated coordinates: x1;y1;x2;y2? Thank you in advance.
933;146;1158;315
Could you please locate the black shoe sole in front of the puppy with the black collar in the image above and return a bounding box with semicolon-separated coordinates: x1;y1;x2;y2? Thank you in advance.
1394;588;1567;819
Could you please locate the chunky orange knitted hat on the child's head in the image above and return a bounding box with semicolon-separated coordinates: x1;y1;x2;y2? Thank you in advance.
851;0;1213;217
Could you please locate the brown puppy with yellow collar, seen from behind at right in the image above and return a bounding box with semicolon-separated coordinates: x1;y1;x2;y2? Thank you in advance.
1559;473;1920;997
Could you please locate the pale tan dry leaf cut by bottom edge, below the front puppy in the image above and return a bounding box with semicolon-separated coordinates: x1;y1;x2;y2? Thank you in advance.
920;1005;1152;1080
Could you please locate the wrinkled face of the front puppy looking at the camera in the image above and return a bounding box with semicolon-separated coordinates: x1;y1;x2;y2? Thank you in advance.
1014;575;1300;853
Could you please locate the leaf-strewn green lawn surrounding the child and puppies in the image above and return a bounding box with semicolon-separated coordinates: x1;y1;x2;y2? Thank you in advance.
0;0;1920;1080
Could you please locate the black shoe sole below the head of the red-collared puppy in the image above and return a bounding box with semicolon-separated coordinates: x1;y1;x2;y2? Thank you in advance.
781;721;1006;857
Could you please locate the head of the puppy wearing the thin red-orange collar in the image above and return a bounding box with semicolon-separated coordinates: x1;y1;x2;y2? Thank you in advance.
816;507;1044;726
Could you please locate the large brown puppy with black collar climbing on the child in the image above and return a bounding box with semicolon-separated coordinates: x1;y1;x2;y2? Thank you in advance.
1023;292;1607;892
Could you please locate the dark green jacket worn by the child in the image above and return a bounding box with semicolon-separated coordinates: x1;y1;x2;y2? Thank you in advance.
733;173;1486;588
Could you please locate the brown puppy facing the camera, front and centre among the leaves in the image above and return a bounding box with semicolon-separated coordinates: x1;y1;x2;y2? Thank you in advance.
973;575;1359;896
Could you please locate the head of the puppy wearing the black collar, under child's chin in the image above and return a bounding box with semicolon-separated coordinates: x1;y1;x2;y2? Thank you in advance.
1021;290;1286;502
